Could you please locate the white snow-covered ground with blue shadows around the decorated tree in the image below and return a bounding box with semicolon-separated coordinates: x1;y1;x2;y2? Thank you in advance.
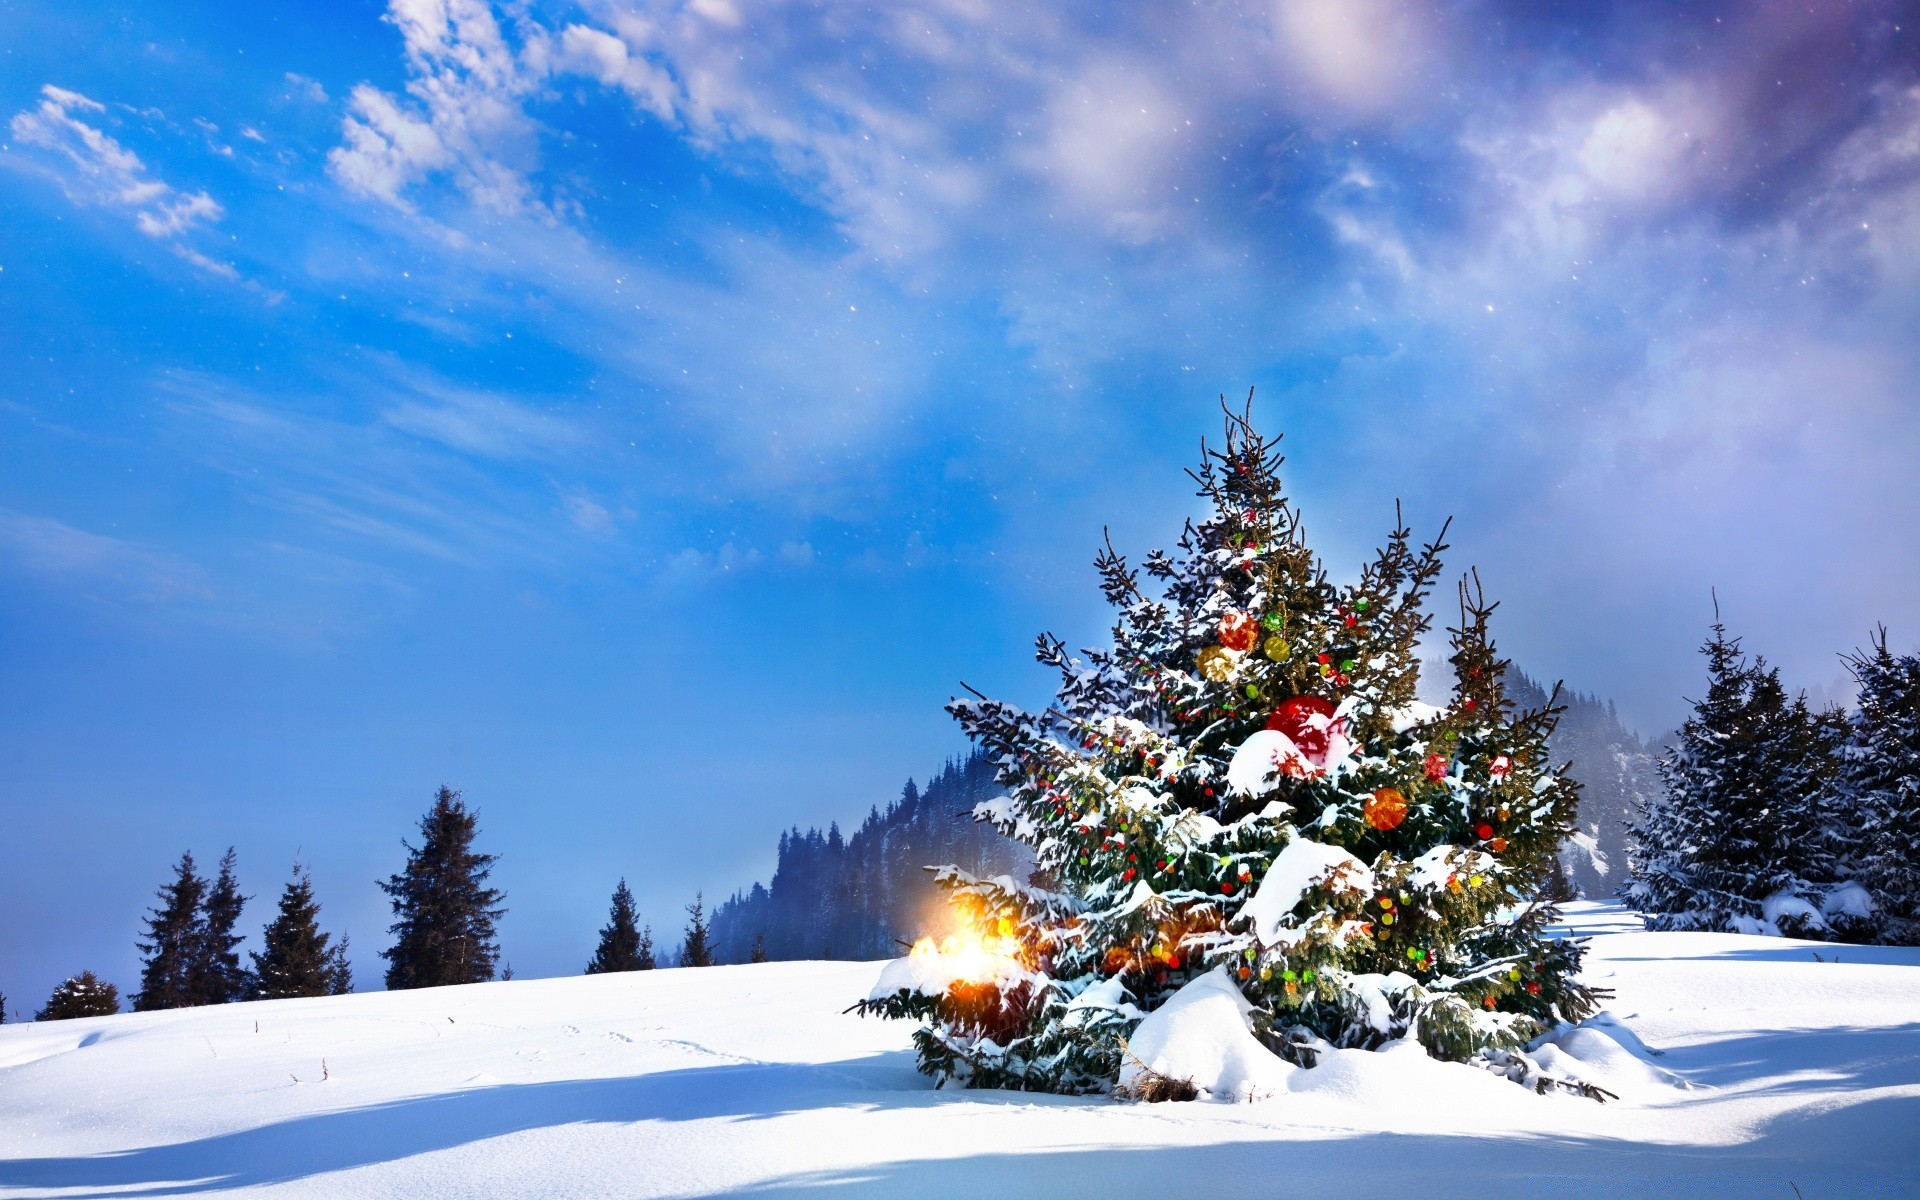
0;904;1920;1200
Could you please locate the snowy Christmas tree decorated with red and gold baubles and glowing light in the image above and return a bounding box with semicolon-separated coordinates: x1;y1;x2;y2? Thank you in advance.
864;411;1594;1092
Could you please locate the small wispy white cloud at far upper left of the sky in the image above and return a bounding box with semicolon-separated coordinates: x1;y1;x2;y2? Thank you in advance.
8;84;236;278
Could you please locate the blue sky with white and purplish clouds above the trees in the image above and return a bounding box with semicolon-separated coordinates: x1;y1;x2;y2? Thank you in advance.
0;0;1920;1008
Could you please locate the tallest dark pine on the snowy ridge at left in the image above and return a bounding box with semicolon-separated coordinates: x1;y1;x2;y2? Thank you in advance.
380;785;507;991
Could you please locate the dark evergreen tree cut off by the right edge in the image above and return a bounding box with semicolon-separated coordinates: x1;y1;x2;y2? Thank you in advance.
1847;628;1920;945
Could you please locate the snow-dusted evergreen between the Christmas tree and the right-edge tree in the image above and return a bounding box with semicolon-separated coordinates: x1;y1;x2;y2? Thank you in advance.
1620;616;1837;937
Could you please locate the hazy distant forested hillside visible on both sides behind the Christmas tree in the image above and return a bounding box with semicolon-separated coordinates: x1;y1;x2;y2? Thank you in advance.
712;668;1659;962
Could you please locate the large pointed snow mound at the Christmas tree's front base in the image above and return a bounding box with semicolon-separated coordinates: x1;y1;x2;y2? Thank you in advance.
1119;966;1300;1100
